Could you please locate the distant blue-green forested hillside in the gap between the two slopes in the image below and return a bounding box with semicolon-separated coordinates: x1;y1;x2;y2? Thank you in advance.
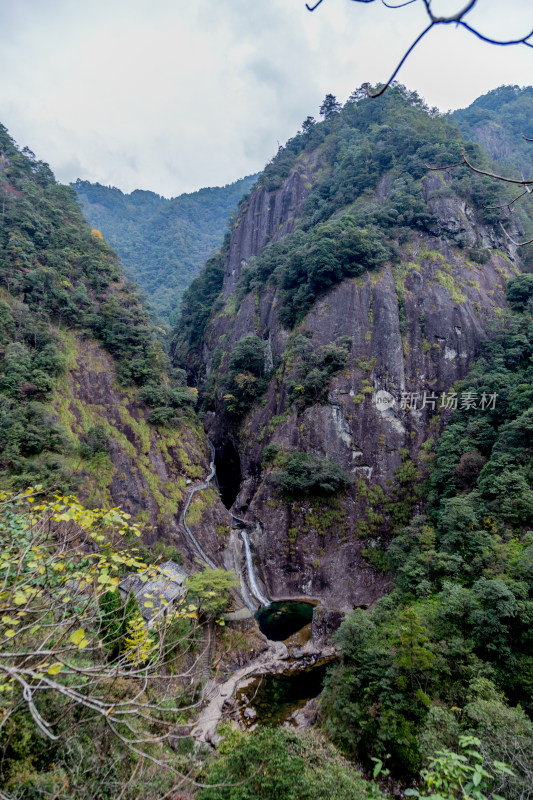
72;175;257;322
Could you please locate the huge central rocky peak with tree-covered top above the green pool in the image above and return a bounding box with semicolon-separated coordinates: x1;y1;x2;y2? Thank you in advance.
174;88;523;608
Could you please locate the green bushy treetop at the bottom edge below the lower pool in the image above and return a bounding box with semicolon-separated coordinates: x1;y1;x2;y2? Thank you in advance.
199;728;368;800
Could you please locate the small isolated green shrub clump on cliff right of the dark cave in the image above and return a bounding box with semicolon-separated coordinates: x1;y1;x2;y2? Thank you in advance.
271;452;351;500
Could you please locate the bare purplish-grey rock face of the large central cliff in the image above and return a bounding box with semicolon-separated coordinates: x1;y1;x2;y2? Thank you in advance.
194;158;519;609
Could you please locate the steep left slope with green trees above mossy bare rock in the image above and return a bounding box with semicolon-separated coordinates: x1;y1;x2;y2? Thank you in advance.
0;122;227;563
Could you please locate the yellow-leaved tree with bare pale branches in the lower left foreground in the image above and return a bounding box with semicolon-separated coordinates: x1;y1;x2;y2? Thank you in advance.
0;487;203;800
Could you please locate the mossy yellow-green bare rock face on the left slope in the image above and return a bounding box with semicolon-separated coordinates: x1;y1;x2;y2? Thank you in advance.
55;337;231;569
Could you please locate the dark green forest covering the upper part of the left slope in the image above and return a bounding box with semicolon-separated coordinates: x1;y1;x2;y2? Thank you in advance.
0;126;170;489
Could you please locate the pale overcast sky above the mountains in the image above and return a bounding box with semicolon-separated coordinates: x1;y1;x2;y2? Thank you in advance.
0;0;533;197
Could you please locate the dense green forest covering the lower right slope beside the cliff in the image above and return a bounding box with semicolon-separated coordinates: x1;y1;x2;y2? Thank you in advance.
323;276;533;800
